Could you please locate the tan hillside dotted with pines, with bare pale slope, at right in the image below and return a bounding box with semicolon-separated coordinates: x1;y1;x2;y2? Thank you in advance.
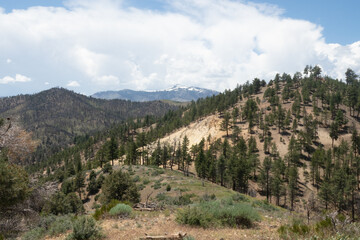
38;67;360;216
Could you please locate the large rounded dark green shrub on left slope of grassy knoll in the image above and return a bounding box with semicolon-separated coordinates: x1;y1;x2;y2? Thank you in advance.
101;170;140;203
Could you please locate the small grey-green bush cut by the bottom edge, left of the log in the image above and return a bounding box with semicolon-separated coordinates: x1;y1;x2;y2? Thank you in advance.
67;216;102;240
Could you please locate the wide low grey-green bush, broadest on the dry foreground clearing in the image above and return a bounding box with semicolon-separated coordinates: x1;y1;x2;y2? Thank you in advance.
176;201;260;228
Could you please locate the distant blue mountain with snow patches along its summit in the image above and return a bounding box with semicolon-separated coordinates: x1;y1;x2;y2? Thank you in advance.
92;85;219;102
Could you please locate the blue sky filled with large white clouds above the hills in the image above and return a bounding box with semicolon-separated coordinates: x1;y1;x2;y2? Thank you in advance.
0;0;360;96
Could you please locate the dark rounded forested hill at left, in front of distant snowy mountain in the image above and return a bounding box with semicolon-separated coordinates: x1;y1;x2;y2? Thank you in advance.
0;88;176;161
